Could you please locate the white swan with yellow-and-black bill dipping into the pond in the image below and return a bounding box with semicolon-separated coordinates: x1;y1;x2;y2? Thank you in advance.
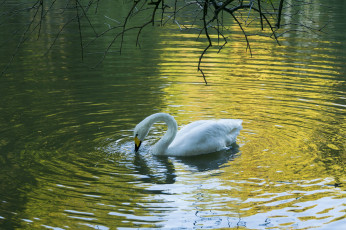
134;113;242;156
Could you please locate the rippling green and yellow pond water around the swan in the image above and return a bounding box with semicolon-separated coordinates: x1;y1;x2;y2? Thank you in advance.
0;1;346;229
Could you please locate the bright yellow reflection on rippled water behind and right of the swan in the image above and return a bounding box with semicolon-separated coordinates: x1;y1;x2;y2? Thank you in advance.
153;18;346;226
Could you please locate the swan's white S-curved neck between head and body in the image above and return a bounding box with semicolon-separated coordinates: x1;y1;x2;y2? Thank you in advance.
147;113;178;155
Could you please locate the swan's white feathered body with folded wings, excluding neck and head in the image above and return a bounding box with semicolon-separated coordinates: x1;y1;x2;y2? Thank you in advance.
167;119;242;156
